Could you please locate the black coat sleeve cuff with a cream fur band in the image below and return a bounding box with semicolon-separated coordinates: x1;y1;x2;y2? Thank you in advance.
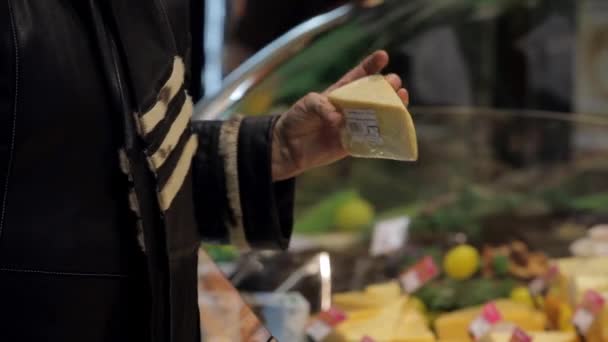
193;117;295;249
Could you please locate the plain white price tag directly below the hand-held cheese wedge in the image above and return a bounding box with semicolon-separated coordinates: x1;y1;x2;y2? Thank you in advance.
369;216;410;256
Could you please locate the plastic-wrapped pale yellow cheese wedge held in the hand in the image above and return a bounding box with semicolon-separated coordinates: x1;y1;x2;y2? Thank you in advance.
329;75;418;160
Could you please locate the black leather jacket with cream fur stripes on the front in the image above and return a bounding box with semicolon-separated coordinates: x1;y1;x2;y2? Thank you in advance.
0;0;293;341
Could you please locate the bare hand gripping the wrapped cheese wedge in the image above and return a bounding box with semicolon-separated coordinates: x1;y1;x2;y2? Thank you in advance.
272;51;408;181
